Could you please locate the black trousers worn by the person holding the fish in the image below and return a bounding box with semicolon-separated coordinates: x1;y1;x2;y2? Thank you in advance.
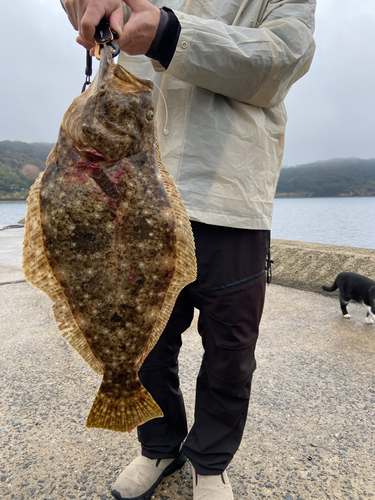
138;222;269;475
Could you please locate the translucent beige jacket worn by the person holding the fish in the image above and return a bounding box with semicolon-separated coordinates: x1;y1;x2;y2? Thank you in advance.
64;0;316;229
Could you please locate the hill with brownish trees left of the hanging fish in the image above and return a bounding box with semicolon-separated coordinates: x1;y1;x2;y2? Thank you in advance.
0;141;53;200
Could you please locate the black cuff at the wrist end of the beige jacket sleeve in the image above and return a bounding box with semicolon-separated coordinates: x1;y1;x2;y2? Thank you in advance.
145;7;181;69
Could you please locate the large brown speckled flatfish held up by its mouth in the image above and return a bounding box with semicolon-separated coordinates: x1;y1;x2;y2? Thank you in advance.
23;47;196;431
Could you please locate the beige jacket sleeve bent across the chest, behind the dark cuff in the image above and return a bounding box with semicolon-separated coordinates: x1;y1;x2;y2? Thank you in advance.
153;0;316;107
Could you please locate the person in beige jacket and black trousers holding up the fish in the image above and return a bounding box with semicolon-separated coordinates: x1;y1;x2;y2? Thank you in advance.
61;0;316;500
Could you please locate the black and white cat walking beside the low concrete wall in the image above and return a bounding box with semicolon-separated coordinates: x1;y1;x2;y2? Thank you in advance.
322;273;375;323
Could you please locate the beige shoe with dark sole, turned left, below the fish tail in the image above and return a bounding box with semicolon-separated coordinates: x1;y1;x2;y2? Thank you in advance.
111;454;187;500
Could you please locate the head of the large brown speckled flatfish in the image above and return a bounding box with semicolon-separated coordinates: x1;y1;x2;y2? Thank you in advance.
66;47;154;162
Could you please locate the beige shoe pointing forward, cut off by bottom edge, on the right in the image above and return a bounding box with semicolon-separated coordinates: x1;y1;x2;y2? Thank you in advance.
193;467;233;500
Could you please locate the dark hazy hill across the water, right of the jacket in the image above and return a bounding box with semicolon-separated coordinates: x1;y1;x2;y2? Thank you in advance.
276;158;375;198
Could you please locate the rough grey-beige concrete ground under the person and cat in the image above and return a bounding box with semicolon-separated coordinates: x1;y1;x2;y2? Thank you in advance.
0;229;375;500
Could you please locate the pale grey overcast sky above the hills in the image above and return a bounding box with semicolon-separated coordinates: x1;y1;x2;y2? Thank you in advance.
0;0;375;165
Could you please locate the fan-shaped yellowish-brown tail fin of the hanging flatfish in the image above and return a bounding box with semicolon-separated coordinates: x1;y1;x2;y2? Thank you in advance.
86;384;163;432
